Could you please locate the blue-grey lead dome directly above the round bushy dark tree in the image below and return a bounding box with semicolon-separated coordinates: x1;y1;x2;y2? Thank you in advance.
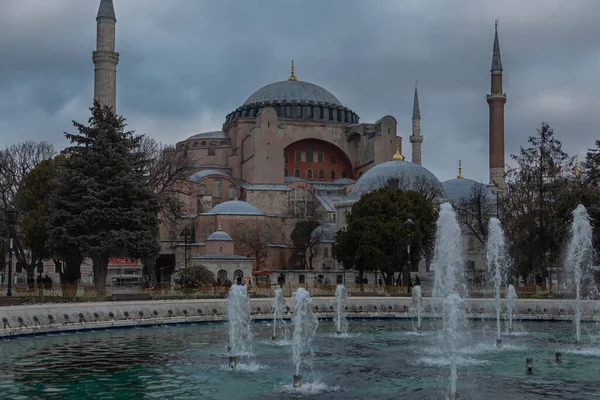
349;160;444;200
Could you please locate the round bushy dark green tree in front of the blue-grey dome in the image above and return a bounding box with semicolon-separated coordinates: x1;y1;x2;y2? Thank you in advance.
333;181;437;284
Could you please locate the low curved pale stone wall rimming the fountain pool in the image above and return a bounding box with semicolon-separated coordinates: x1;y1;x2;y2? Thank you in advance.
0;297;600;338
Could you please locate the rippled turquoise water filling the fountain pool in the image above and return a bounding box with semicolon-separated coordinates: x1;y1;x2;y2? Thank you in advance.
0;320;600;400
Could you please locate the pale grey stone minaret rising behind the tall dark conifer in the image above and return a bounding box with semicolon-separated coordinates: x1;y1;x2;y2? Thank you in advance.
92;0;119;112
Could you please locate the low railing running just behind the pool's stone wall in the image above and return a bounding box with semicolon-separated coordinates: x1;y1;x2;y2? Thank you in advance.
0;283;587;305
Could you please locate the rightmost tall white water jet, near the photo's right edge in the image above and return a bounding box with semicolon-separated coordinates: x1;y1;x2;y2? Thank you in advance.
565;204;593;348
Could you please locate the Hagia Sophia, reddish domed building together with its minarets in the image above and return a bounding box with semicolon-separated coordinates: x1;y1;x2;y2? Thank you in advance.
93;0;506;282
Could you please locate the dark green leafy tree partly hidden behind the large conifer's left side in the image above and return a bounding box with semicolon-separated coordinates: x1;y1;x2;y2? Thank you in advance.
15;156;64;275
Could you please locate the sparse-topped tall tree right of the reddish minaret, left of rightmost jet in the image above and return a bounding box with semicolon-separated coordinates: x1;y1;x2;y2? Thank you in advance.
504;123;573;276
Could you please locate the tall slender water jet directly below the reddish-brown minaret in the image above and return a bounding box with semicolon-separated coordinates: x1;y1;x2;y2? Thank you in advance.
485;218;507;347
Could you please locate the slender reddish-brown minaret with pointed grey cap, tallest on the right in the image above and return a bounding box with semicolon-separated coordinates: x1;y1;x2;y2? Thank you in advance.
487;20;506;192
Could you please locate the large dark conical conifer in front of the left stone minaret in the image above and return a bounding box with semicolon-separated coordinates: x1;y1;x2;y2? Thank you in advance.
48;101;159;295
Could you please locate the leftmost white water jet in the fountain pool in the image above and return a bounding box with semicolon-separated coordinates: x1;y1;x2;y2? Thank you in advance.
227;285;252;369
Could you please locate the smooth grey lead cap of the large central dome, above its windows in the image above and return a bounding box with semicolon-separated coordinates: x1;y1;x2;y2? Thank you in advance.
244;80;342;106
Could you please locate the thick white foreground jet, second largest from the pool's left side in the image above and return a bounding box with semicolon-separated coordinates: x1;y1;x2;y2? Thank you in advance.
292;288;319;387
